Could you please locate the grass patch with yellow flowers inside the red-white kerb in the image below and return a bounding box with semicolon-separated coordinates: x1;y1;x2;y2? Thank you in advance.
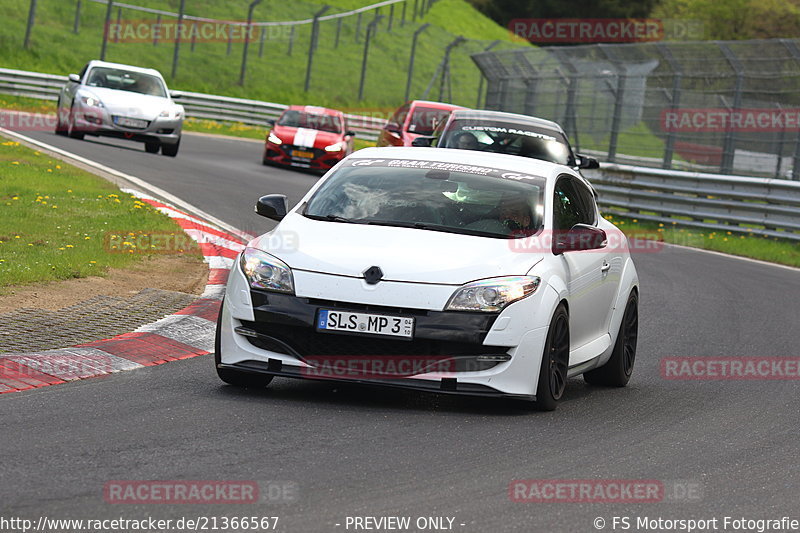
0;138;199;290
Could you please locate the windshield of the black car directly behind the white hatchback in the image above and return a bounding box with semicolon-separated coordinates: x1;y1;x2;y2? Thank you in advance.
439;119;575;166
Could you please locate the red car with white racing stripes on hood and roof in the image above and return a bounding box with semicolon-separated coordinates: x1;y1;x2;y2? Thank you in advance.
263;105;355;171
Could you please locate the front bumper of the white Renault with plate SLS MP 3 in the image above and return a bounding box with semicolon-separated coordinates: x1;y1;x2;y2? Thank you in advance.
218;258;555;400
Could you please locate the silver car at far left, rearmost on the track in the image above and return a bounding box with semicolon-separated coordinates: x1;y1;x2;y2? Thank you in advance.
56;61;185;157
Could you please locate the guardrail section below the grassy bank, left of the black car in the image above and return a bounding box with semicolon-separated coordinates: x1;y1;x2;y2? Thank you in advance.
0;68;386;141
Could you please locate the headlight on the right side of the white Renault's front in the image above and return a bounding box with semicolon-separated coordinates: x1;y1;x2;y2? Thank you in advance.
445;276;541;313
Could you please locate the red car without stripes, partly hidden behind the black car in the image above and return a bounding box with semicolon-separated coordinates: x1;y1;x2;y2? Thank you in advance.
378;100;464;146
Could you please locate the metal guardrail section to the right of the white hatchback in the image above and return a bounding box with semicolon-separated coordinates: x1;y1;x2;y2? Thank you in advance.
584;163;800;241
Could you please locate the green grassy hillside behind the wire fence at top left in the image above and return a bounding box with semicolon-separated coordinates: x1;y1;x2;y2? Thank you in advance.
0;0;527;110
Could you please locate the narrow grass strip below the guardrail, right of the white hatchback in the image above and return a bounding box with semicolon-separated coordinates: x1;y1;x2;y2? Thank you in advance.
606;215;800;267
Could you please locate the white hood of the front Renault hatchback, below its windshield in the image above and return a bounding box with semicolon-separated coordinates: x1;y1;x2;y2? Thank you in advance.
249;213;543;285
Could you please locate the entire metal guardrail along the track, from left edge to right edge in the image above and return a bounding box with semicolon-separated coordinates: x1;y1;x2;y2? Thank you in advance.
0;69;800;241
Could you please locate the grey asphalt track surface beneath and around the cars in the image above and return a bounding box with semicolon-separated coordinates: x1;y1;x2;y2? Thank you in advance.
0;133;800;532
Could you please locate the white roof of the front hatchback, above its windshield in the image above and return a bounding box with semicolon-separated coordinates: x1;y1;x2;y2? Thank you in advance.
348;146;580;178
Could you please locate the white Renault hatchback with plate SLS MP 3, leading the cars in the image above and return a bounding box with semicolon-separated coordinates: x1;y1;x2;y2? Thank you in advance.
215;148;639;410
